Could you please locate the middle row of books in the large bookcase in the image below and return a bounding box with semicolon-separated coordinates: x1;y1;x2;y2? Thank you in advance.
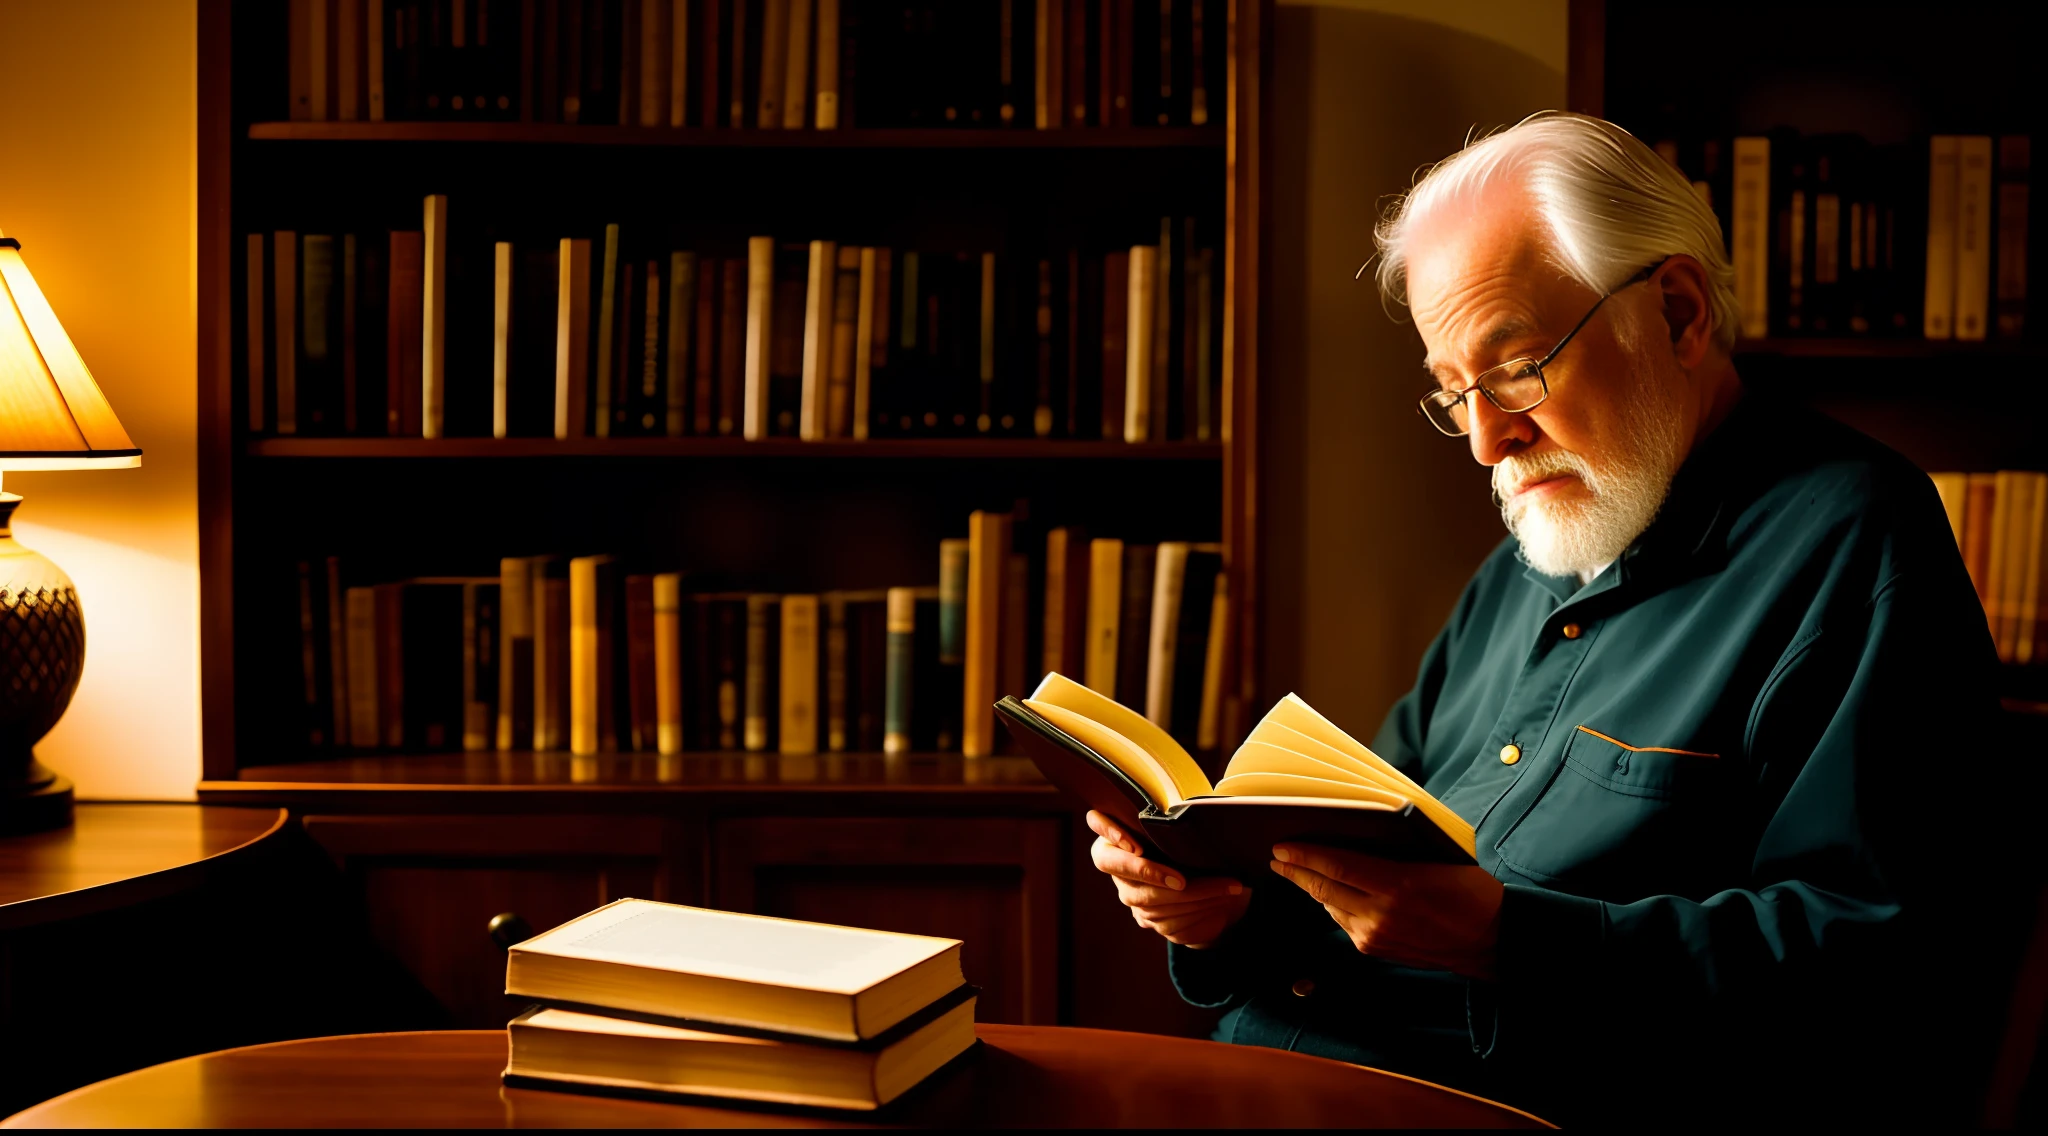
242;194;1223;442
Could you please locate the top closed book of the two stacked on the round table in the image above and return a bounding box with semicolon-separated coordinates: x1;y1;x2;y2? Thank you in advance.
506;899;963;1042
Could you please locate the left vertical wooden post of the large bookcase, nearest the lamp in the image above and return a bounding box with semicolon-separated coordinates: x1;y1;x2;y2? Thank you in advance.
195;0;236;778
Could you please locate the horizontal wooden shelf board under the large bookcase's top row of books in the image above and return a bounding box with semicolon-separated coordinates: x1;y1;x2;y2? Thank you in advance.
248;123;1227;149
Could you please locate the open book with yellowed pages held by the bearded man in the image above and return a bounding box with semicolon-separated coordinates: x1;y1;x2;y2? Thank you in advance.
995;673;1473;880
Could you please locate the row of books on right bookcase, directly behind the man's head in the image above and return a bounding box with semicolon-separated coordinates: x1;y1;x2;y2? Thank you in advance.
1657;131;2030;340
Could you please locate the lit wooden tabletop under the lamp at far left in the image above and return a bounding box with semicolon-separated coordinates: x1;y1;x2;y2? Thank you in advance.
0;804;285;931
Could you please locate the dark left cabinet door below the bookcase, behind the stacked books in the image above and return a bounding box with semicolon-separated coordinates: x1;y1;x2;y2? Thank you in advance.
305;817;692;1030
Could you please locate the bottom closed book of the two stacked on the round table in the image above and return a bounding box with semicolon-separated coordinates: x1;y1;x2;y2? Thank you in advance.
506;987;975;1109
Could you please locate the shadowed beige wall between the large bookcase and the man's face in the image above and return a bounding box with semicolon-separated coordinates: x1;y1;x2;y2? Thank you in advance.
1260;0;1565;737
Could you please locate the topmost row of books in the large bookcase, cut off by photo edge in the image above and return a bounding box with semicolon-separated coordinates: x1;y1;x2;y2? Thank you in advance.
285;0;1229;131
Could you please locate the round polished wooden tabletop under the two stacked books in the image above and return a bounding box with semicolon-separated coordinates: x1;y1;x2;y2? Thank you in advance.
0;1025;1548;1128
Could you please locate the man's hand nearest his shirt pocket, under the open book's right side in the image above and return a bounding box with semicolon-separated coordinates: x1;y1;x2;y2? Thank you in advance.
1261;843;1503;980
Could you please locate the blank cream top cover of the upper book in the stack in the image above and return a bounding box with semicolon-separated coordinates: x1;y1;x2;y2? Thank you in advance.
514;899;958;993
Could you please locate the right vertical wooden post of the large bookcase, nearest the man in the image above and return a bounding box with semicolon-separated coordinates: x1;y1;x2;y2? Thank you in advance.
1219;0;1274;753
